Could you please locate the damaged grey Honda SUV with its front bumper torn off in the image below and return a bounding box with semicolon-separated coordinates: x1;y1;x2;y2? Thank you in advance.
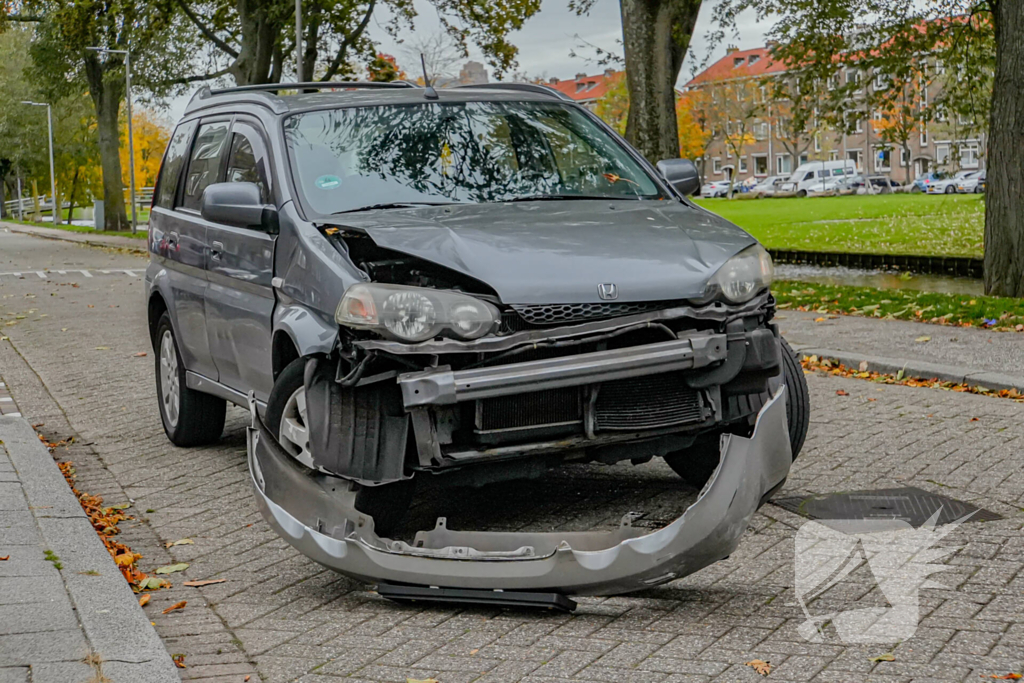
145;83;809;600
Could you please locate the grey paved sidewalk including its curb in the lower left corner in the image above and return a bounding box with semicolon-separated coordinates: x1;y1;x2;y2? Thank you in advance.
0;416;178;683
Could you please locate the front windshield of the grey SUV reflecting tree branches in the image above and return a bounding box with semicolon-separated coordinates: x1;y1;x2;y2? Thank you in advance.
285;101;664;215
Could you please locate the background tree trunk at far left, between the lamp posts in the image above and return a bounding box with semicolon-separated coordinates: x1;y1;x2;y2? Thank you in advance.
85;54;129;230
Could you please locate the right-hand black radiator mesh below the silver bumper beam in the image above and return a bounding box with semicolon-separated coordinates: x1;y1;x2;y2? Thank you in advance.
594;373;707;431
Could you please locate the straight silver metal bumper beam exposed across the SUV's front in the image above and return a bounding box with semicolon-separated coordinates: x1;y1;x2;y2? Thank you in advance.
398;334;728;408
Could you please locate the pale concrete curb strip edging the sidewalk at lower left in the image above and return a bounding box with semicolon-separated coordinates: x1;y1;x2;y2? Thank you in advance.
0;416;180;683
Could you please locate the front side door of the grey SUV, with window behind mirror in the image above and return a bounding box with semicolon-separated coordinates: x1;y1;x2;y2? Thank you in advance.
206;117;275;400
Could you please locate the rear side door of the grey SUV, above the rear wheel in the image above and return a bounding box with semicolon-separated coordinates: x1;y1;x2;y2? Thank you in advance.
150;121;227;377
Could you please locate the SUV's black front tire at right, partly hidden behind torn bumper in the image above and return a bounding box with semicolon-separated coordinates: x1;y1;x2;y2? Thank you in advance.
665;339;811;488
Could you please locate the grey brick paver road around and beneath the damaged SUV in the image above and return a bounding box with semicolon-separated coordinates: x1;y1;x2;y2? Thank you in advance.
0;227;1024;683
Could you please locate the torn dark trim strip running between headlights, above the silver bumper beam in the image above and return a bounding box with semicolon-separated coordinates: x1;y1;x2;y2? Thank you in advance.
352;293;773;355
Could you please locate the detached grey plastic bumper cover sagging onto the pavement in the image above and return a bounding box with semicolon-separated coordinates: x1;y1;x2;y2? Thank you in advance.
247;386;793;595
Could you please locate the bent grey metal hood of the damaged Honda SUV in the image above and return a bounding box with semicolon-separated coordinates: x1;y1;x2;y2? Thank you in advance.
337;201;755;304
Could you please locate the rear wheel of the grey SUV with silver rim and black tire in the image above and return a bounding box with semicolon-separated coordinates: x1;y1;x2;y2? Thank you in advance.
153;312;227;446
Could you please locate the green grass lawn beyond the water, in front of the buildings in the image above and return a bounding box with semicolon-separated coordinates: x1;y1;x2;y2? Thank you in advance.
697;195;985;258
